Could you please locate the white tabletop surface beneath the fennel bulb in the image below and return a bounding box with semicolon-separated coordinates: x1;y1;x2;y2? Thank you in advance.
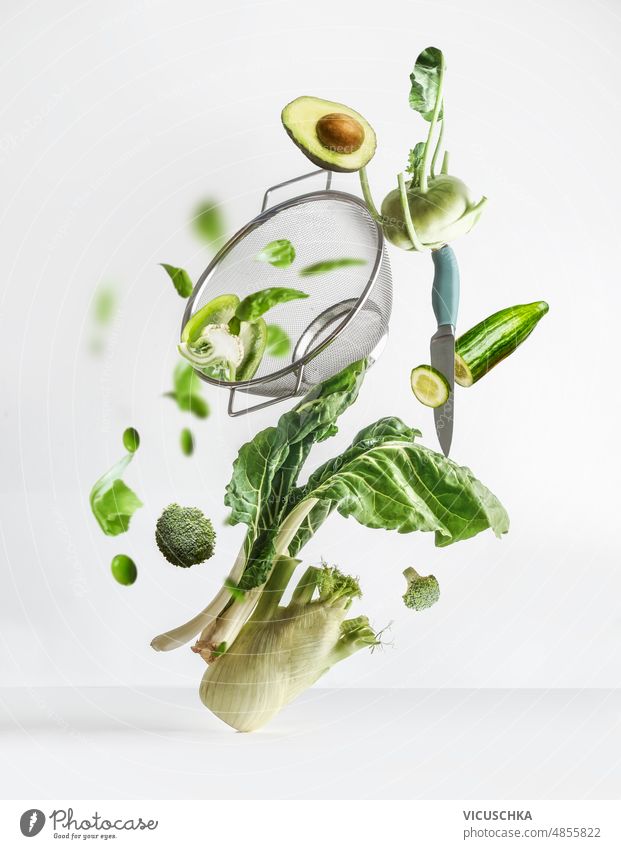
0;688;621;800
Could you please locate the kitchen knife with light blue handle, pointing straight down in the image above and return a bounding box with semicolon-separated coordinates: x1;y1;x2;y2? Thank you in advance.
430;245;459;457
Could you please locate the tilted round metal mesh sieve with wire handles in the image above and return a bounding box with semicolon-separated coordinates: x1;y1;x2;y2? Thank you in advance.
182;169;392;416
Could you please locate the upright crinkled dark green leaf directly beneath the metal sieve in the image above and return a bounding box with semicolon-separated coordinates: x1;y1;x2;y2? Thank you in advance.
225;361;365;589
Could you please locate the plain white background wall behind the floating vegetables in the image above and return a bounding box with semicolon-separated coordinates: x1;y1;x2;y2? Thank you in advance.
0;0;621;688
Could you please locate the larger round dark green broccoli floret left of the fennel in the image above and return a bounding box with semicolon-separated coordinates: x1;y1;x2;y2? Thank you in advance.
155;504;216;568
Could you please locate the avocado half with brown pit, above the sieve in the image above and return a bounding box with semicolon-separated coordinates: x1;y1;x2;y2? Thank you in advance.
281;95;377;172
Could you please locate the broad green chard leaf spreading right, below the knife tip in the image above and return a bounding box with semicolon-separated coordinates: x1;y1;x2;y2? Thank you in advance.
303;419;509;546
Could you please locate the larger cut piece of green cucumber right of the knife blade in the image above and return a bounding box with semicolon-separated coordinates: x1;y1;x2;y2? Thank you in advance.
455;301;549;386
